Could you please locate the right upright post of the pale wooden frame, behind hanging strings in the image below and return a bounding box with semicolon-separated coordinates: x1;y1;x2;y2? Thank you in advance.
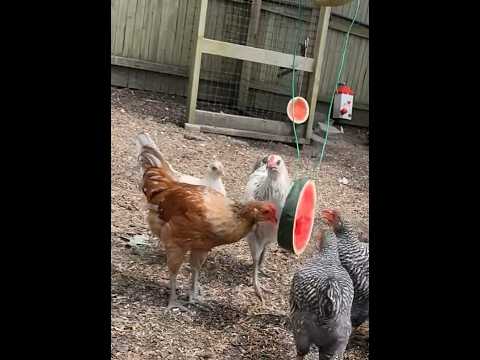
305;7;331;141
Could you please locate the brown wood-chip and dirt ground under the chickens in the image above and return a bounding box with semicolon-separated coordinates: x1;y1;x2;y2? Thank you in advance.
111;88;369;360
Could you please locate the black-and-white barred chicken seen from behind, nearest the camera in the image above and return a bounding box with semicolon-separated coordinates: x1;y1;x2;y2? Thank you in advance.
290;230;354;360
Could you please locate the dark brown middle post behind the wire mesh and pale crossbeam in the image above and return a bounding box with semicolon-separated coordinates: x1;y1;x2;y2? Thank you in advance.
238;0;262;110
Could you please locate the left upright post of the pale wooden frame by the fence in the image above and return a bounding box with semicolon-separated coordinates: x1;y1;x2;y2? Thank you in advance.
187;0;208;124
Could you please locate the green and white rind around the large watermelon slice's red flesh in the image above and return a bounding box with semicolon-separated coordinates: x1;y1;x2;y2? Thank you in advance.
277;178;316;255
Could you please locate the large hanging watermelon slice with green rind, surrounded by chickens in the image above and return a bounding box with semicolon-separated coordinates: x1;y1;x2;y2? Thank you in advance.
277;179;317;255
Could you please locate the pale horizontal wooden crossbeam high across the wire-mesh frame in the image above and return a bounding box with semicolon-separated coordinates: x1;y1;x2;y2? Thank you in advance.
199;38;314;72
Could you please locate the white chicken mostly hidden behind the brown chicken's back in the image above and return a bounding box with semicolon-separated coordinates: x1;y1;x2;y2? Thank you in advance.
137;133;226;196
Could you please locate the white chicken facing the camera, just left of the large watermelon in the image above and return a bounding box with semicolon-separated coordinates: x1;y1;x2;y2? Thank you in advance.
245;155;291;301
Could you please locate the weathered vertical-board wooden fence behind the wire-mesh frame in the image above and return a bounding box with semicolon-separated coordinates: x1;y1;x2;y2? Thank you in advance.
111;0;369;125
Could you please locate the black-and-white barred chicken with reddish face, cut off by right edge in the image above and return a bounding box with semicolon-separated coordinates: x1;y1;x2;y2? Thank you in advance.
321;209;369;328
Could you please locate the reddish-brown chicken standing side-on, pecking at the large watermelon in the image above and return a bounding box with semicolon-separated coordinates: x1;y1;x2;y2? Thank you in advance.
138;136;277;309
